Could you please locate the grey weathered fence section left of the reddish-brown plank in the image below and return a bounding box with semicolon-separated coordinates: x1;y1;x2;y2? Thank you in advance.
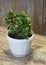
0;0;34;26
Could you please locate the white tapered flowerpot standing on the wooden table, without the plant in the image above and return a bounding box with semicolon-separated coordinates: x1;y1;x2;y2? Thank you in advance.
6;32;34;57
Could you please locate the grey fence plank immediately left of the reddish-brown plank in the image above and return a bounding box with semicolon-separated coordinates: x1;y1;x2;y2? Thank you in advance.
27;0;34;29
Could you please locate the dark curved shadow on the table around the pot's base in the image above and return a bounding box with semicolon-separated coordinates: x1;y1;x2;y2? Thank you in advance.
4;50;33;63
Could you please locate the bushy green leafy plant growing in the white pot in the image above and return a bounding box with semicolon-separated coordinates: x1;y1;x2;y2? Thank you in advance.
4;10;33;39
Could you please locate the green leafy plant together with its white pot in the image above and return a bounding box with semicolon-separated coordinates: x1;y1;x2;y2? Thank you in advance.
4;10;34;57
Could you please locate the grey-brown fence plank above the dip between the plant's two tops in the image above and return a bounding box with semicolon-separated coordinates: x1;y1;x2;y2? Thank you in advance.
15;0;27;13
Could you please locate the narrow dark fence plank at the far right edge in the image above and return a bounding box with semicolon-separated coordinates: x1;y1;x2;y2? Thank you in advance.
43;0;46;35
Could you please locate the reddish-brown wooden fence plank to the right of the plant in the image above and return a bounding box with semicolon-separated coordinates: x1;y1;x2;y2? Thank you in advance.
34;0;43;34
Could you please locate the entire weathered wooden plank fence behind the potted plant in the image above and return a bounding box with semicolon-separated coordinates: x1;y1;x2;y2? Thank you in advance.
0;0;46;34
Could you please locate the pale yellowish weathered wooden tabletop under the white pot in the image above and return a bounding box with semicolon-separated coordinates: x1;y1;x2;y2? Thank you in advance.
0;26;46;65
